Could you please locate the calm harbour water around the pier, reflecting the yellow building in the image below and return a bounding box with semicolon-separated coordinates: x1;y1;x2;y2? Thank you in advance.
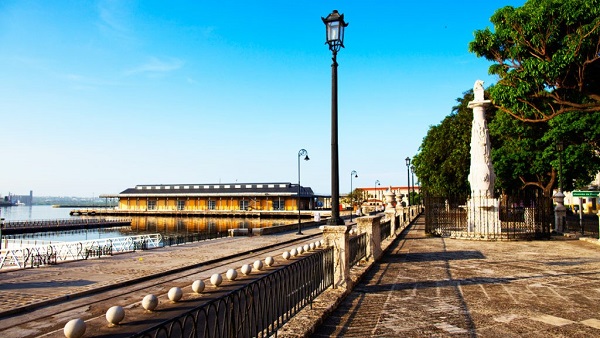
0;205;296;241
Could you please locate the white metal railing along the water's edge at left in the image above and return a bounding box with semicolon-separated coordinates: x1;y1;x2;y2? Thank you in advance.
0;234;162;269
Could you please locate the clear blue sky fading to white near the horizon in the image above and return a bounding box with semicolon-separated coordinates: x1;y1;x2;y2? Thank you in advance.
0;0;524;197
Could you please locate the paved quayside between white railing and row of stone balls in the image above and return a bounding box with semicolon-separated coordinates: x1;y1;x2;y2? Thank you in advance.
0;227;321;320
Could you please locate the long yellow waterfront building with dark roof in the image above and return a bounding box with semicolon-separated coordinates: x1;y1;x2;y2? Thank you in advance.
100;183;322;211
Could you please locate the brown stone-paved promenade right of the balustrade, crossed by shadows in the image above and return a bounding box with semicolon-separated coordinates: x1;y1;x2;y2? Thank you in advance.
312;217;600;337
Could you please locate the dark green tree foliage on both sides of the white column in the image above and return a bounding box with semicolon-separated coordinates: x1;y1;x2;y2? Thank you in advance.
413;90;600;196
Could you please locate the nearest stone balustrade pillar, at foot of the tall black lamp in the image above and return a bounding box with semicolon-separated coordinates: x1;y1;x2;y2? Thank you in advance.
323;226;352;288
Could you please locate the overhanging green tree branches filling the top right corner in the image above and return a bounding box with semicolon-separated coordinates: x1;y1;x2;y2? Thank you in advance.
469;0;600;122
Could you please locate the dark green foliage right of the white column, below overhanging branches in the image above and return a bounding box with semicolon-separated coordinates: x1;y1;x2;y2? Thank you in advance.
489;100;600;196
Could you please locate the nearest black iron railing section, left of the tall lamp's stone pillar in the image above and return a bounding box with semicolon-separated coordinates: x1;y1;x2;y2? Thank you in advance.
134;247;333;338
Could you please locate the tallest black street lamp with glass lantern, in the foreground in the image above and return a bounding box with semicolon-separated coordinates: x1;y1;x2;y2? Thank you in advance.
321;10;348;225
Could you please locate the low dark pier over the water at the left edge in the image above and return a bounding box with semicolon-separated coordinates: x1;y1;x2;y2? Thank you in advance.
2;218;131;235
